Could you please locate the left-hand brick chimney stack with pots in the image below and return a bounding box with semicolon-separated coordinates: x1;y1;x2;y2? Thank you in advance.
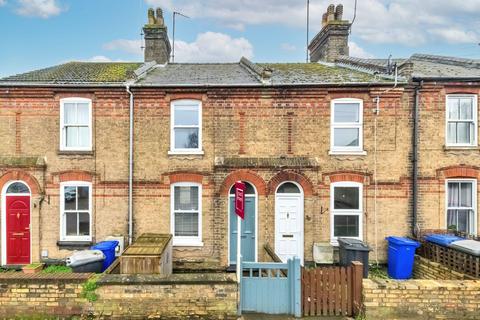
143;8;172;64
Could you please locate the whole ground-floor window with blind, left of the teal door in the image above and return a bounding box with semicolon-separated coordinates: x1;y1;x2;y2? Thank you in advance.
171;183;202;246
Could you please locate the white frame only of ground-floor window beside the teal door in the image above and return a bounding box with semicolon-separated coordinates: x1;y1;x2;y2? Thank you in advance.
170;182;203;247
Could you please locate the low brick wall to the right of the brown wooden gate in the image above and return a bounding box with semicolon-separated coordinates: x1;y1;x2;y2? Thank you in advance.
363;279;480;320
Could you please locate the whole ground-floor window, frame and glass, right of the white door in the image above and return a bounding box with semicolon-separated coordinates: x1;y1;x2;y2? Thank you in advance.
330;182;363;242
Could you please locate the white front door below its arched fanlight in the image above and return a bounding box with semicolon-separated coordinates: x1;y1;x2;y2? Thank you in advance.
275;194;303;264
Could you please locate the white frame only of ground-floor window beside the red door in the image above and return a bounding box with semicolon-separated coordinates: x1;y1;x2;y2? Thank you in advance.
59;181;93;241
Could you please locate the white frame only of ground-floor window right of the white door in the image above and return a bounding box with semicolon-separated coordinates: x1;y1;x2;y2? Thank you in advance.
330;181;363;246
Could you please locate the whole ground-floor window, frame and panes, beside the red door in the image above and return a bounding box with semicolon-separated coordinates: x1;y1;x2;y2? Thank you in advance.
60;182;92;241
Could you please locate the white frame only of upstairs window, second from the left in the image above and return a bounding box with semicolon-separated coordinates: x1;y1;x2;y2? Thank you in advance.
168;100;203;154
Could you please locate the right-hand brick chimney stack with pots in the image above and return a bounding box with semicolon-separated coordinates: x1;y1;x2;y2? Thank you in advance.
308;4;350;62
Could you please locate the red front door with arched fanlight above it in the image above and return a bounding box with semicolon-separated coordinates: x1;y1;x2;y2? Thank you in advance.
4;181;30;265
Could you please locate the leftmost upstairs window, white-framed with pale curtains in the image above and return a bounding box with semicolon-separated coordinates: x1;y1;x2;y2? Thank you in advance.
60;98;92;151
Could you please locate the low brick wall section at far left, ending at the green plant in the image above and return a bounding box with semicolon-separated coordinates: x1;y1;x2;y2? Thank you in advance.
0;272;91;319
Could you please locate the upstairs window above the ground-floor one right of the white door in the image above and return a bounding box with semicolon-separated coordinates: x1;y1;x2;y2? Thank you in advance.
330;99;363;153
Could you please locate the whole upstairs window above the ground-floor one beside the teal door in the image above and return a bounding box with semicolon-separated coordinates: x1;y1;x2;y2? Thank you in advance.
170;100;202;153
